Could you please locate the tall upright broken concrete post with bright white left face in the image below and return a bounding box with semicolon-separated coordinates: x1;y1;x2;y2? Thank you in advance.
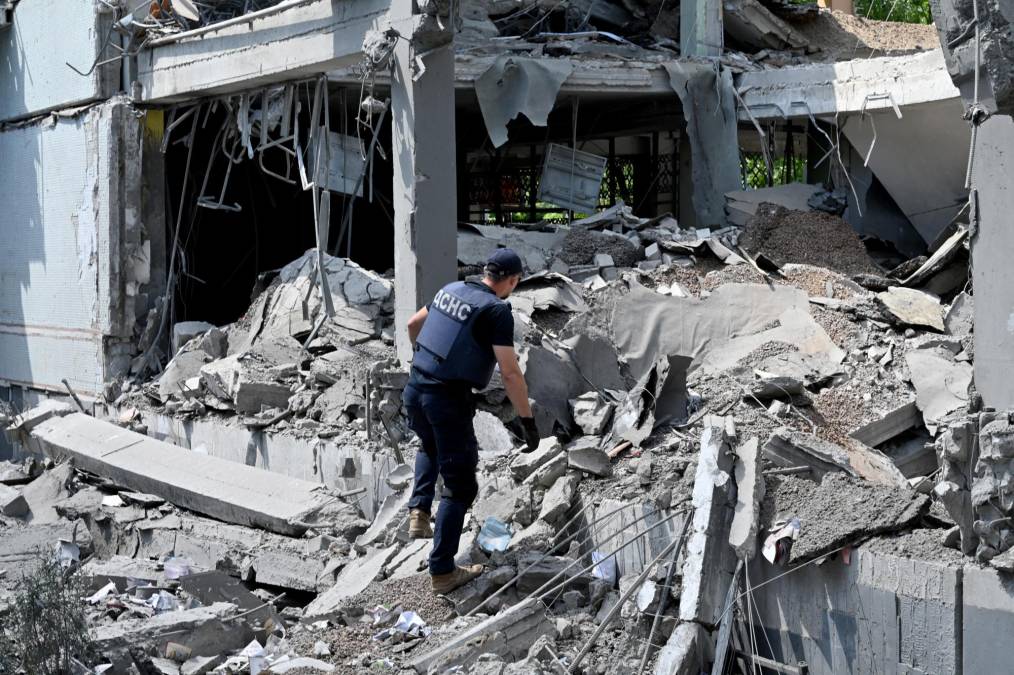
679;416;736;625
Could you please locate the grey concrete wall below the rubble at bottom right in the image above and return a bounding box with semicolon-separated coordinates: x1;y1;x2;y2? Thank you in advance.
750;547;961;675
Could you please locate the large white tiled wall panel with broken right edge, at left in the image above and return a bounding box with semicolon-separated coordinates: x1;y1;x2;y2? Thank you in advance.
0;100;157;394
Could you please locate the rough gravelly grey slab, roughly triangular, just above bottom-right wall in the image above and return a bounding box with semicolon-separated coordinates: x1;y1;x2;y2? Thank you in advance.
762;471;930;565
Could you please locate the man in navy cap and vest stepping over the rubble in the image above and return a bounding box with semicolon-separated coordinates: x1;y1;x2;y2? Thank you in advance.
403;248;539;594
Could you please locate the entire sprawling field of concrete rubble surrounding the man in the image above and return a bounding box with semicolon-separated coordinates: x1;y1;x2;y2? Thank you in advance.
0;198;981;673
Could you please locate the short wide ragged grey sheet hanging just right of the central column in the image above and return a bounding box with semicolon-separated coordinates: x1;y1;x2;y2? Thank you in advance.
476;55;574;148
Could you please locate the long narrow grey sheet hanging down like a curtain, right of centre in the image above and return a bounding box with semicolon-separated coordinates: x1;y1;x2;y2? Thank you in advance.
663;61;740;226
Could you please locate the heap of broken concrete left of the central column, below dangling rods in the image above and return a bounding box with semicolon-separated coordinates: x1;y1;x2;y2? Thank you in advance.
110;249;404;439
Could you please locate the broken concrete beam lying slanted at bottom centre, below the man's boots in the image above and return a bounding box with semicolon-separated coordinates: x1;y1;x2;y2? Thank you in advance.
409;598;554;673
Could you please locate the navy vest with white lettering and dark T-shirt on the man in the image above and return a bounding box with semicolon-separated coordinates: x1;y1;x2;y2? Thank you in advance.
412;282;506;389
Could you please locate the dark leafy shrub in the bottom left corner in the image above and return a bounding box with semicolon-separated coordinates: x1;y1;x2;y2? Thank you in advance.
0;557;90;675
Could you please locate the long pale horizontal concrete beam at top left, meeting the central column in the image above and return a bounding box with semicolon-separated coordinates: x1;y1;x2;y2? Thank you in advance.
136;0;390;103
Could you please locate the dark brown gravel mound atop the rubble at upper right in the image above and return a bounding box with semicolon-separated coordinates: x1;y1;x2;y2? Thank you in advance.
739;203;878;275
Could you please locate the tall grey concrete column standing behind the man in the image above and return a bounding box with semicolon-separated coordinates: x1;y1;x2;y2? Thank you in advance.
391;27;457;364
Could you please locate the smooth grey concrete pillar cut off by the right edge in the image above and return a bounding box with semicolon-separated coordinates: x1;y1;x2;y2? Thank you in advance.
971;116;1014;409
